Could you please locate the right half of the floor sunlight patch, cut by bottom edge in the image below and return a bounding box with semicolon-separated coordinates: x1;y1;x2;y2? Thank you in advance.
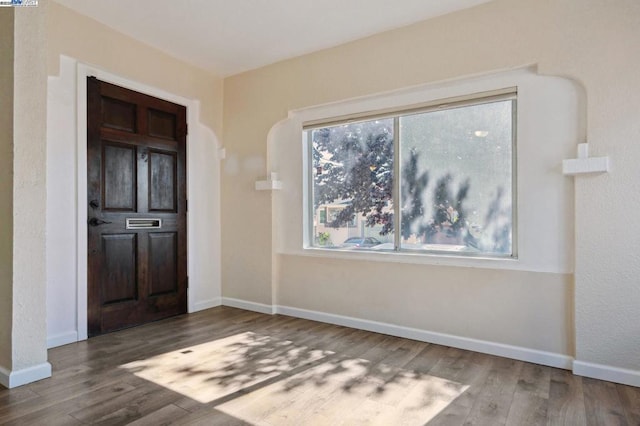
217;359;468;426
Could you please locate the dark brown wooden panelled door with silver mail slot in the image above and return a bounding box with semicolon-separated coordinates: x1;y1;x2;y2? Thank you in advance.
87;77;187;336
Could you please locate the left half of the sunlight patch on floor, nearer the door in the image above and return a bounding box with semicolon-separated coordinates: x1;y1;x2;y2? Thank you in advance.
122;332;332;404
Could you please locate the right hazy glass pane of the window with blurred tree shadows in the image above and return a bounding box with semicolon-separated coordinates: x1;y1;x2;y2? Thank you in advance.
399;100;513;254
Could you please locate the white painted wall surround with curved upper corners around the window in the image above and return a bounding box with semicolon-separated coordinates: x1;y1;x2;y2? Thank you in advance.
269;68;584;273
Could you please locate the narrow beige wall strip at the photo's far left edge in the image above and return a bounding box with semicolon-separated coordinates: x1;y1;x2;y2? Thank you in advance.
0;8;14;370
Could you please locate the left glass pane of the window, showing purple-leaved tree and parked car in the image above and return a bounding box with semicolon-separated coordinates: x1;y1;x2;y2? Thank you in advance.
310;119;394;249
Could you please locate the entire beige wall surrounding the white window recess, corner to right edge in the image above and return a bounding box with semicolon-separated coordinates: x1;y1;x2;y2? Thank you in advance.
222;0;640;371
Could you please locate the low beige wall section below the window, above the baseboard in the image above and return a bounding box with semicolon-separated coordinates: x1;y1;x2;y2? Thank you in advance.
278;255;573;354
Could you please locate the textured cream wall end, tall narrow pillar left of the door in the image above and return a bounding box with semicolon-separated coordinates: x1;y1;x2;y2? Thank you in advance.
12;1;47;371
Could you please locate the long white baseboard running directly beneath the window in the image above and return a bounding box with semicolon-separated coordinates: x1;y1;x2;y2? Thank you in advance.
276;306;573;370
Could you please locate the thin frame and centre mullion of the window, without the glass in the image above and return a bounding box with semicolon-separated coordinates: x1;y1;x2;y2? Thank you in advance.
302;86;519;260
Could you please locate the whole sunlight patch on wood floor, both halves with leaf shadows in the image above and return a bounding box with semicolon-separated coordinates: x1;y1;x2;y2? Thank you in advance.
122;332;468;426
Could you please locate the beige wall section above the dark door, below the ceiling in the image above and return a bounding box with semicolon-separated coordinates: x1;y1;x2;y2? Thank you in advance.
47;2;223;136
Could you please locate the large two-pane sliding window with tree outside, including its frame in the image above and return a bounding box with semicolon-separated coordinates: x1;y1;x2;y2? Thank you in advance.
305;93;516;257
